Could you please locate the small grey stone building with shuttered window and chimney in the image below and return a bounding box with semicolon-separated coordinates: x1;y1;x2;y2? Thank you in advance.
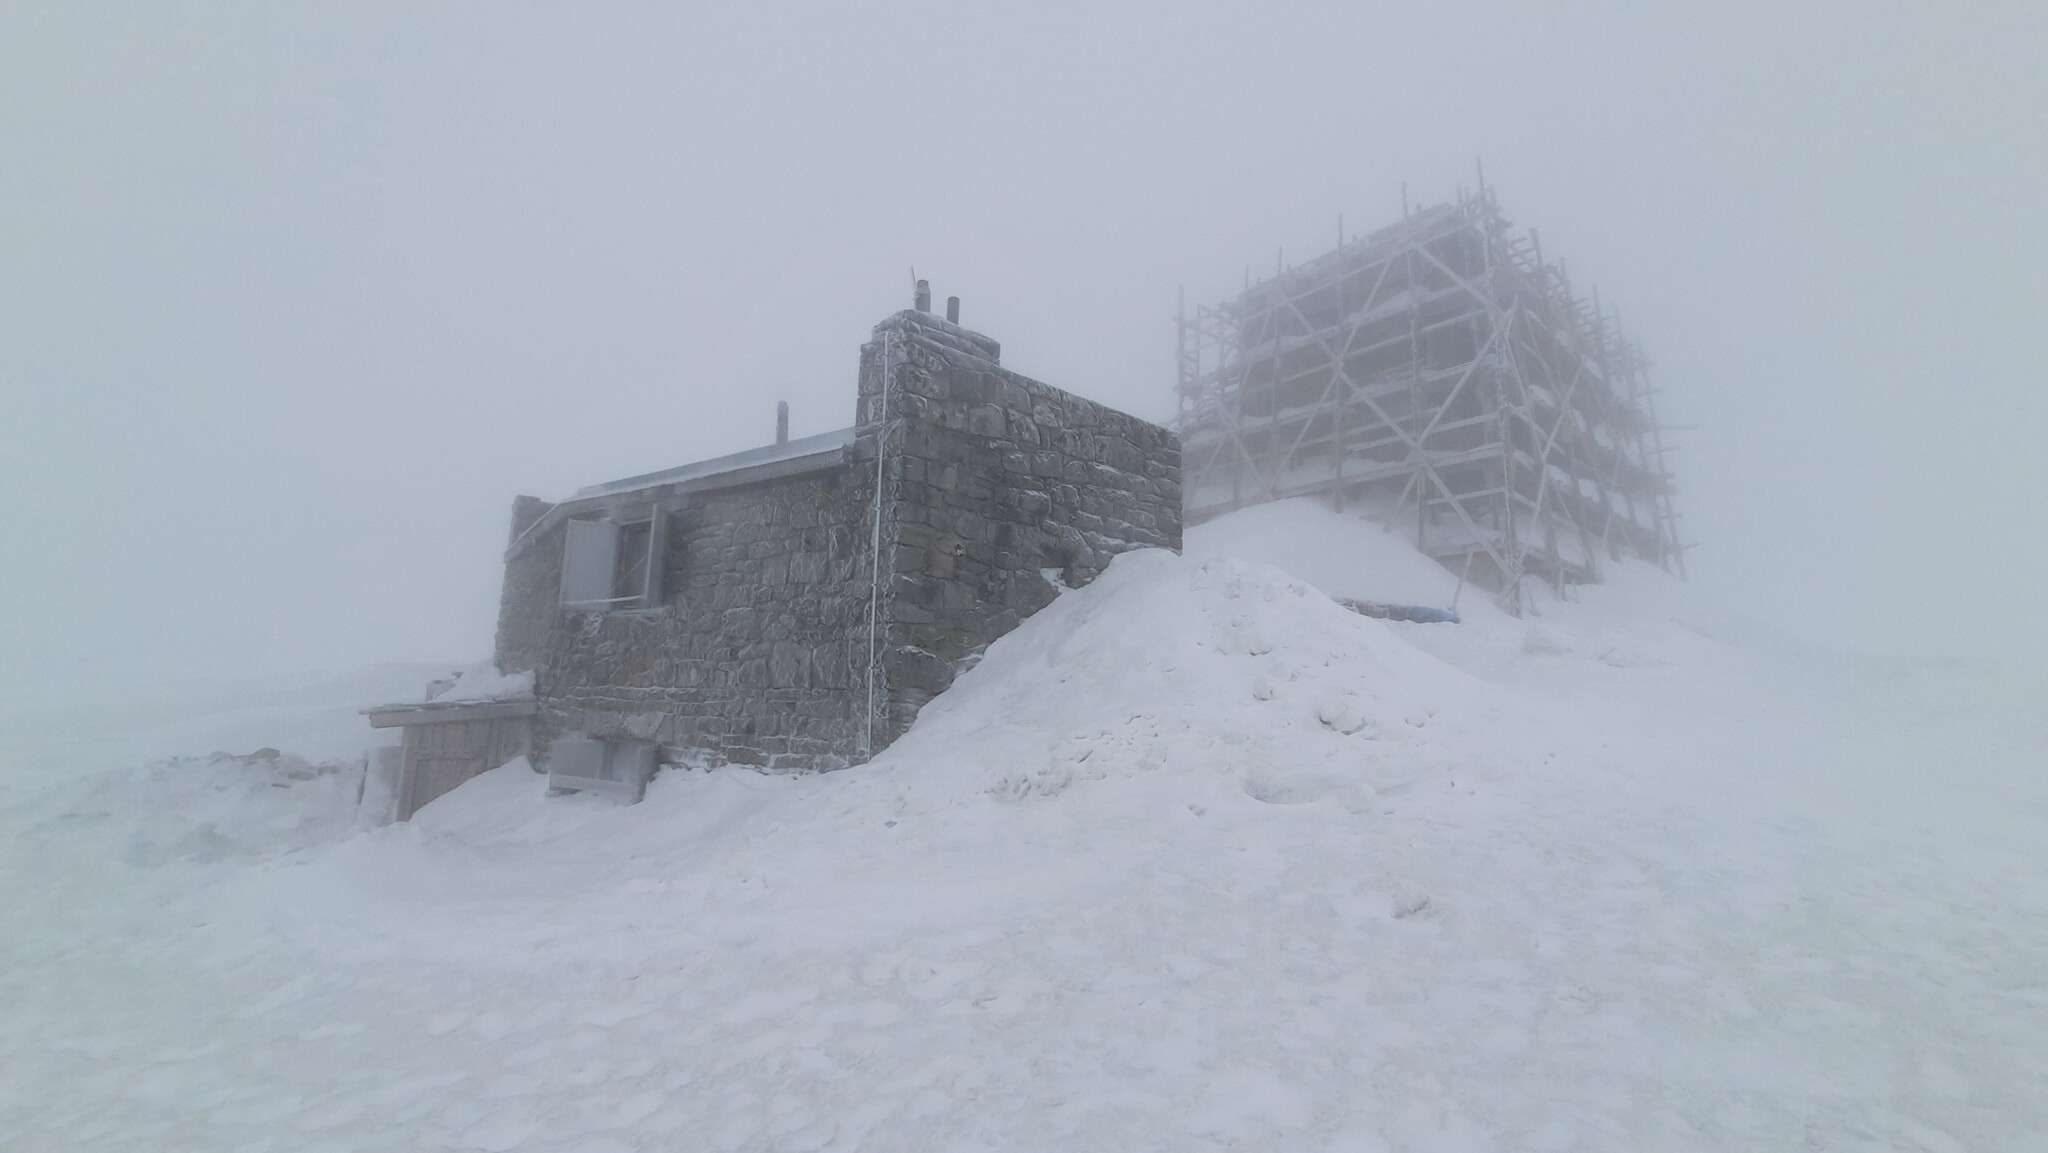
483;301;1182;786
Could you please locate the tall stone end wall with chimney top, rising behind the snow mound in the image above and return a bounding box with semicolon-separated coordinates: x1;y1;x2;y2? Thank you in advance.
860;311;1182;743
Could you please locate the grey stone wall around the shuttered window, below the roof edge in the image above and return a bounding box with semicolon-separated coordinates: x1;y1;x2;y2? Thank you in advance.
498;465;872;768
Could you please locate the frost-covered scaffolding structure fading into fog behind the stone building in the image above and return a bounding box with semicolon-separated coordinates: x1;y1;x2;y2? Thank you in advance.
1180;180;1686;602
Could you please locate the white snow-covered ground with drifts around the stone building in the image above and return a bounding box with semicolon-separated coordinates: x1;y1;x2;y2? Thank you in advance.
0;506;2048;1153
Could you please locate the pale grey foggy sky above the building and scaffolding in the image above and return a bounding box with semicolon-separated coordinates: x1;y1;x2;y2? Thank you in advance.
0;0;2048;696
